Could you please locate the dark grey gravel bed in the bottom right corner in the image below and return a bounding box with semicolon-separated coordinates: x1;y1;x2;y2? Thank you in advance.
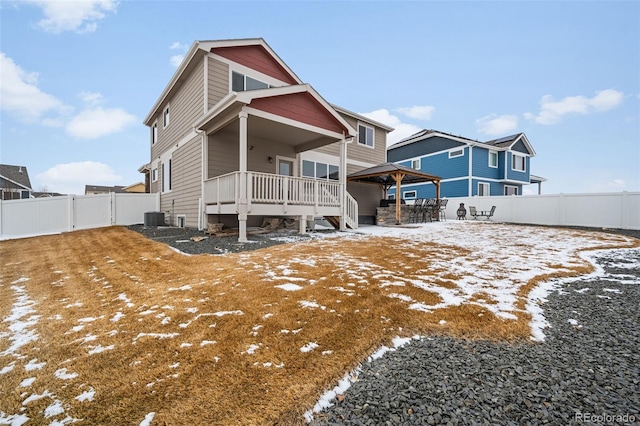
311;249;640;426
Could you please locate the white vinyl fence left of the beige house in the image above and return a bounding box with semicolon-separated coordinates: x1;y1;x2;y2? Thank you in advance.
0;193;160;240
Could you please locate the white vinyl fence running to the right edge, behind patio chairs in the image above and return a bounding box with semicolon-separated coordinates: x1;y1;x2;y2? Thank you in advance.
446;191;640;229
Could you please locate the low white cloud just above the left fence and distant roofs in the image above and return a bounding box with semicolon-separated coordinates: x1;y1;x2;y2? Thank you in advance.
36;161;122;194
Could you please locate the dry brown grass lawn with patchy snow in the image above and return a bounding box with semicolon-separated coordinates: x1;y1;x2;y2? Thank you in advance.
0;228;630;425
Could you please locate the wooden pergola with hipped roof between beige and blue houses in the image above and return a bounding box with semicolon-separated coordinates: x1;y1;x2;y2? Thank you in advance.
347;163;441;225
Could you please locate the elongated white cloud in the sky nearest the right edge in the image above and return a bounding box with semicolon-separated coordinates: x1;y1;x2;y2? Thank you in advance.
524;89;624;125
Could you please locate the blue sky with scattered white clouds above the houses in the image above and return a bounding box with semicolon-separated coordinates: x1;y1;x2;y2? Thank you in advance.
0;0;640;194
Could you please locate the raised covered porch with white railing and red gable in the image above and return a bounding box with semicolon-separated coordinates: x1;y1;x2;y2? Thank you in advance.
196;85;358;242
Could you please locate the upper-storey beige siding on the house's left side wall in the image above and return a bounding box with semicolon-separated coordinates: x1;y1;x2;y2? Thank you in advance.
151;54;204;159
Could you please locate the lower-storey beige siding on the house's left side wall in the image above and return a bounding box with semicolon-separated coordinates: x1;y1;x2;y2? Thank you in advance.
160;136;202;227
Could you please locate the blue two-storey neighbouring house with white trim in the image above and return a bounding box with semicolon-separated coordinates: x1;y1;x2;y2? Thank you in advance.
387;130;546;199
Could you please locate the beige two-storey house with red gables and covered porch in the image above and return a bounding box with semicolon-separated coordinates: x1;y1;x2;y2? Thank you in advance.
139;38;393;241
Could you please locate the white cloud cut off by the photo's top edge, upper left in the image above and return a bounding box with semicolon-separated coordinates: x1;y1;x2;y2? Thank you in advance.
27;0;118;34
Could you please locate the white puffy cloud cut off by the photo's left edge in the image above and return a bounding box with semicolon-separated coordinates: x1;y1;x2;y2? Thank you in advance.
0;52;68;122
